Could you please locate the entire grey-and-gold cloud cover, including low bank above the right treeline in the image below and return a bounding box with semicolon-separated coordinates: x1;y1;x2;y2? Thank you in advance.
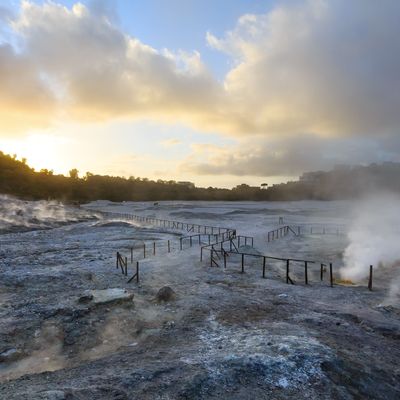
0;0;400;175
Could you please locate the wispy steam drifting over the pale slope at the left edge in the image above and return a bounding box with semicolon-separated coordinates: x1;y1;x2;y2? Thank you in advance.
0;195;95;233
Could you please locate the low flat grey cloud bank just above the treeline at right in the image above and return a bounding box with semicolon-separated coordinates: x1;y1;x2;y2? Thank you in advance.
179;134;400;177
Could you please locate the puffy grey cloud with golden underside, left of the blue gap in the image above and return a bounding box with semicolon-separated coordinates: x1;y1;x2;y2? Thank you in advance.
10;2;219;129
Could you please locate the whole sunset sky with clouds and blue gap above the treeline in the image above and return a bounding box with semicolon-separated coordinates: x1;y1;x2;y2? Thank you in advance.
0;0;400;187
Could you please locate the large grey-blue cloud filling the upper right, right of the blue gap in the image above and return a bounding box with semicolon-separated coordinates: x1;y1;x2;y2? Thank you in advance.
207;0;400;136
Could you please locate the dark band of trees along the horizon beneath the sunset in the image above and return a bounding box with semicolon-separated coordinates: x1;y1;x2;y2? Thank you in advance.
0;152;400;202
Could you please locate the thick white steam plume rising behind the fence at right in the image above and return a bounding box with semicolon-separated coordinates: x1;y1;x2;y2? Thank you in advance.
340;193;400;282
